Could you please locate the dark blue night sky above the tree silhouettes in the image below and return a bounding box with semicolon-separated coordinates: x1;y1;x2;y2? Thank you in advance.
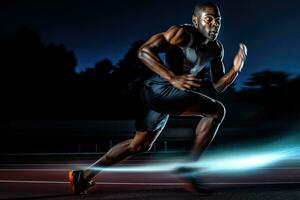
0;0;300;88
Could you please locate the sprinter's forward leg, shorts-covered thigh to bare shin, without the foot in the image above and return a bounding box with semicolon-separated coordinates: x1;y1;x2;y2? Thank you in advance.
143;85;225;160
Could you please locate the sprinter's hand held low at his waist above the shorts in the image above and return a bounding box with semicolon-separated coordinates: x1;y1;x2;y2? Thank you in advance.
169;74;202;91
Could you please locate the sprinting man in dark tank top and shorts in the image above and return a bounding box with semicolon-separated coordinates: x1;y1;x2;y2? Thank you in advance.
69;2;247;194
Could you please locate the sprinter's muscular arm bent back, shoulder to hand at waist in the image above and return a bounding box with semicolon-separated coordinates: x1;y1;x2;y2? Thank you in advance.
138;26;200;90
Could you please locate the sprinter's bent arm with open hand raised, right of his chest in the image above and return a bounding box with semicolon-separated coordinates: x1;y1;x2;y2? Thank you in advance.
211;44;247;92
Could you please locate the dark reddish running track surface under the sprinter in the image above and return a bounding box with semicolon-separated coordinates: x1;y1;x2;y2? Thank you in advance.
0;157;300;200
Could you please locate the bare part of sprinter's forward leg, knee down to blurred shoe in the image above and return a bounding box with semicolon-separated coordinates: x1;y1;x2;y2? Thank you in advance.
172;93;226;194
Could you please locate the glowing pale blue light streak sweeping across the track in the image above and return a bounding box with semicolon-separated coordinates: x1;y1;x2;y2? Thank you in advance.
93;147;300;173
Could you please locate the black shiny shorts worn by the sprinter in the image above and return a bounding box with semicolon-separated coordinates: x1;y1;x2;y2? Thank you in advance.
135;83;214;131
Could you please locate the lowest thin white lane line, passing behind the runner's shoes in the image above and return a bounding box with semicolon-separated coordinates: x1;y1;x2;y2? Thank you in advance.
0;180;300;186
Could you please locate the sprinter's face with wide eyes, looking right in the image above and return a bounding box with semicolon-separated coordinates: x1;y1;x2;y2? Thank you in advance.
193;7;221;41
